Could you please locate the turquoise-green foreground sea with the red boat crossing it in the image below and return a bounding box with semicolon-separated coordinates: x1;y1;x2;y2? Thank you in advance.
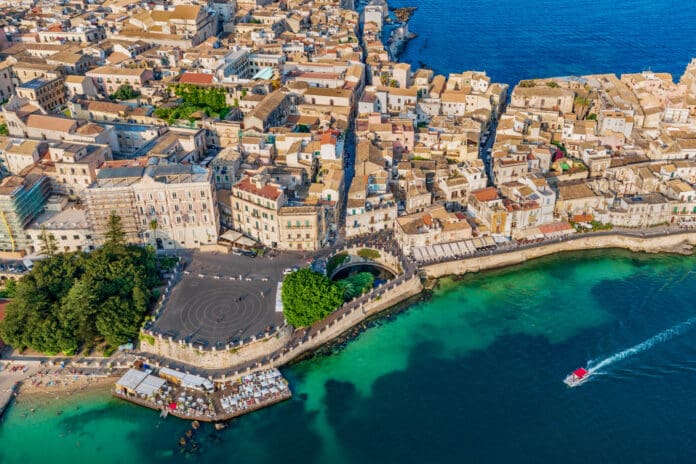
0;251;696;464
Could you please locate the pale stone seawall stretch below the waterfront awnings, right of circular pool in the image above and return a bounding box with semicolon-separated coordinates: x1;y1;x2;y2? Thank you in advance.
421;232;696;278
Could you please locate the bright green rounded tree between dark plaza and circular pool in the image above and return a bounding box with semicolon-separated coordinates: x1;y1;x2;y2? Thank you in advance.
281;269;343;327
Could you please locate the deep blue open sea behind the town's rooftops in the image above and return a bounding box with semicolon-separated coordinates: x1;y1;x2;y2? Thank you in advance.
389;0;696;85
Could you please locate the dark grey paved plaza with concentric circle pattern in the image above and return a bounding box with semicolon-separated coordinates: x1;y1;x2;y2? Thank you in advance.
152;253;301;347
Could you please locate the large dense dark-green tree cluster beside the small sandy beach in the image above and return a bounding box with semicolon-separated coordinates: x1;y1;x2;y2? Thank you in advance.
0;216;159;355
